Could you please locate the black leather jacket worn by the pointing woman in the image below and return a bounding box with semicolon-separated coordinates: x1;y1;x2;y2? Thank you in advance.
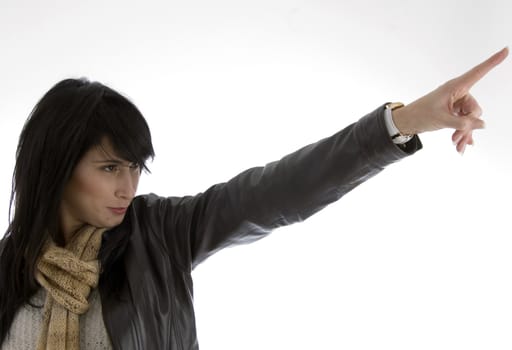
5;106;422;350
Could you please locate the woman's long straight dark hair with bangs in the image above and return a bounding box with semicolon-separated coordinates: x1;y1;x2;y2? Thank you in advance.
0;78;154;344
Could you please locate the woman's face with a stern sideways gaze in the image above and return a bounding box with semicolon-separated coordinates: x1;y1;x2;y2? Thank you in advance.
60;141;140;241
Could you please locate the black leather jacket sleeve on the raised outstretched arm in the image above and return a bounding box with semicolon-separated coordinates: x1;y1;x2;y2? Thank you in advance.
139;106;422;271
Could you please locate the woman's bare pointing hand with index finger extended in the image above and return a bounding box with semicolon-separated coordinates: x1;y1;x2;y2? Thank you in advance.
393;48;508;153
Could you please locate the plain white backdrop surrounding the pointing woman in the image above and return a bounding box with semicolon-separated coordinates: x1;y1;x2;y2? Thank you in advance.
0;0;512;350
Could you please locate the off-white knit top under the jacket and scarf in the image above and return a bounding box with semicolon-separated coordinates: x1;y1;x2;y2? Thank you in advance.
1;288;112;350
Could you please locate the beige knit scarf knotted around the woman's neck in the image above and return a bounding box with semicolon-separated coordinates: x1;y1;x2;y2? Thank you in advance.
36;226;105;350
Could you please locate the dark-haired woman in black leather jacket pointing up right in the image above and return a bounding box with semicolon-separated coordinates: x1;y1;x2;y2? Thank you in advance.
0;49;508;349
